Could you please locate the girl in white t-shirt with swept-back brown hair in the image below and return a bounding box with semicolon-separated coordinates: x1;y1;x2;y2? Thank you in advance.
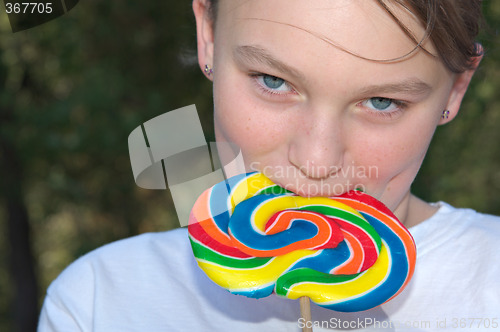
40;0;500;331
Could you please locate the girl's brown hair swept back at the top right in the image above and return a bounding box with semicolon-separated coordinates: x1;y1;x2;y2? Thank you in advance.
207;0;482;73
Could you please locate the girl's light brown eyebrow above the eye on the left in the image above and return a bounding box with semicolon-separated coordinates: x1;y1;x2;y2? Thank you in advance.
233;45;305;80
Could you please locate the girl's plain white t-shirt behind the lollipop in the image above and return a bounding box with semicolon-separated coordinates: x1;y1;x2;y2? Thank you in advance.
39;203;500;332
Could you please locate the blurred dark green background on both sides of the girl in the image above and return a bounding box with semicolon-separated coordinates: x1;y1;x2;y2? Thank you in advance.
0;0;500;331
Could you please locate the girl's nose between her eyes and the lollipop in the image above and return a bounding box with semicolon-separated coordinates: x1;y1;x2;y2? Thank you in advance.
288;111;345;180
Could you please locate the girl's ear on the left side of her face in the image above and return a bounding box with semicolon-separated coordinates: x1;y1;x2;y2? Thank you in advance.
193;0;214;79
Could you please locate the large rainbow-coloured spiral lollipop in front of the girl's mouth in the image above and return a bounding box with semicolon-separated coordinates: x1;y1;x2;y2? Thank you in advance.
189;173;416;311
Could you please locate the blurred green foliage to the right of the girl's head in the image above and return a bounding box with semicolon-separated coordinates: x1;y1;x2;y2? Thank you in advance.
413;0;500;215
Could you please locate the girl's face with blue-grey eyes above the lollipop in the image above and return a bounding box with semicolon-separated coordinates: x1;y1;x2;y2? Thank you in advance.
193;0;472;226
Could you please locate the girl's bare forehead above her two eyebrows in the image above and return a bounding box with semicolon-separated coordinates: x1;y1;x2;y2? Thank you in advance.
217;0;434;60
